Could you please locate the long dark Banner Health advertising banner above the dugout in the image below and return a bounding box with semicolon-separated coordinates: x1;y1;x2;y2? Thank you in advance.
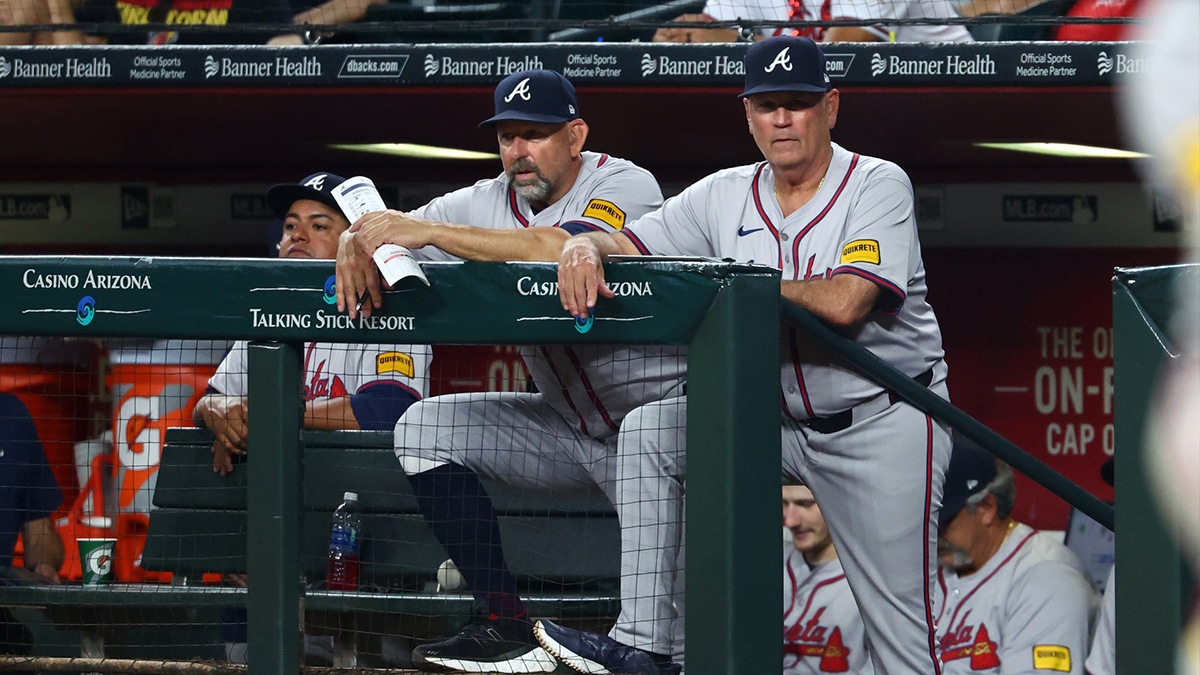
0;42;1148;89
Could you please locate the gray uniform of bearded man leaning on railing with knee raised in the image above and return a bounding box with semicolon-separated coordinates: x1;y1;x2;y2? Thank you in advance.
396;153;686;653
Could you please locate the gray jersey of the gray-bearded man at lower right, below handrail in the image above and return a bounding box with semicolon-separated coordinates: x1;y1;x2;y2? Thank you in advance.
937;524;1096;675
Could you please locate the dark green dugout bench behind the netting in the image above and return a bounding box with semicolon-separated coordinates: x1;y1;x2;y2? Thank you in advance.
0;429;620;667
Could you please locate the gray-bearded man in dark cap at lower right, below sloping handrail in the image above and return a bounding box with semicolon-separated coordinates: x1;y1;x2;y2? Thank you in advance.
934;436;1096;675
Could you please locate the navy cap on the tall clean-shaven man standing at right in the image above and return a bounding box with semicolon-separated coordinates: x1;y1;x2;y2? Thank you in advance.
739;35;833;98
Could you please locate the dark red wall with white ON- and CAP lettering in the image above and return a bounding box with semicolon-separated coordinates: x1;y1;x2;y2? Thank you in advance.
924;243;1178;530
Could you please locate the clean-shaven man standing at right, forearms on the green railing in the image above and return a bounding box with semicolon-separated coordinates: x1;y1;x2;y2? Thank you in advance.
556;36;950;675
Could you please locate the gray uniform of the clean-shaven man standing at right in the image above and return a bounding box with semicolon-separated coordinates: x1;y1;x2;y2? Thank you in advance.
619;139;950;675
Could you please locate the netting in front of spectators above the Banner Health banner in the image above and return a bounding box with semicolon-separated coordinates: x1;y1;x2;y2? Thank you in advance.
0;0;1141;44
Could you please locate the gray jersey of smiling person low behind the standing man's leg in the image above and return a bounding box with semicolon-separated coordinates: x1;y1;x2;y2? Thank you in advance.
784;540;875;675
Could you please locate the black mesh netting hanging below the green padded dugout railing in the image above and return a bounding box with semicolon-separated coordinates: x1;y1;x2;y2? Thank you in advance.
0;338;684;671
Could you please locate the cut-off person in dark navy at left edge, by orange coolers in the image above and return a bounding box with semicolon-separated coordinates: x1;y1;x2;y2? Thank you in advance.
0;394;64;667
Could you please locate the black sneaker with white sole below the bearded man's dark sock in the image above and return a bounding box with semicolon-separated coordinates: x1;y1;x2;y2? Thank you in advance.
413;617;558;673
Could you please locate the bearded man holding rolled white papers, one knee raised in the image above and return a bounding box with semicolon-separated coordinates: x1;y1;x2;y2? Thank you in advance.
337;70;686;675
